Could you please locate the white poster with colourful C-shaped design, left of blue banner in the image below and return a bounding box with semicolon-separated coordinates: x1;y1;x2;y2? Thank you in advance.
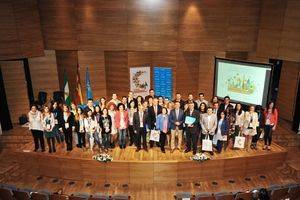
130;66;150;97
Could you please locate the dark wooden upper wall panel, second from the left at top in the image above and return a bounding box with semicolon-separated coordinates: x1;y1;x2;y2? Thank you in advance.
38;0;77;50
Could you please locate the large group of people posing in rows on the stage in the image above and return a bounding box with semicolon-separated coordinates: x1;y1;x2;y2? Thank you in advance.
28;89;278;154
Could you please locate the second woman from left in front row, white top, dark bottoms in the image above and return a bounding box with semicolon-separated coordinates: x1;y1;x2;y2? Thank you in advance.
42;106;56;153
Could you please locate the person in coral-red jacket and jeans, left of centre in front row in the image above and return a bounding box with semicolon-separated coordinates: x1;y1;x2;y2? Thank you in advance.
115;103;128;149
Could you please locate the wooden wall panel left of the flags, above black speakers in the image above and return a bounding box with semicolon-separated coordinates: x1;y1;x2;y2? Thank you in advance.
28;50;59;99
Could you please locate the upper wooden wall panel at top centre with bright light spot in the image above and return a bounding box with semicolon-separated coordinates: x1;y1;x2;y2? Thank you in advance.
127;0;178;51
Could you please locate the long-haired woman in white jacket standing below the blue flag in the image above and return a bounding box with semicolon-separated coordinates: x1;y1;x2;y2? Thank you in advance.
84;110;97;152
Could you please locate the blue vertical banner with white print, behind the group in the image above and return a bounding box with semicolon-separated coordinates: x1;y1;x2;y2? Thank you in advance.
153;67;173;99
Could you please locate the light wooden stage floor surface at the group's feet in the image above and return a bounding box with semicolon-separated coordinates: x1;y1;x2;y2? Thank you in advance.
18;128;286;162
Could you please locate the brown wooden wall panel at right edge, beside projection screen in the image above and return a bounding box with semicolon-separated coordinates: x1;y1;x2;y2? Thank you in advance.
277;61;300;121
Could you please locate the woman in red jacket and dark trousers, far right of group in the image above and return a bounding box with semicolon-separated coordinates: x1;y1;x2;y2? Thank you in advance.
263;102;278;150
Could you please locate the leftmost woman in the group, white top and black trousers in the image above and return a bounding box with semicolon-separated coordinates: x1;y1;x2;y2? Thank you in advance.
28;105;45;152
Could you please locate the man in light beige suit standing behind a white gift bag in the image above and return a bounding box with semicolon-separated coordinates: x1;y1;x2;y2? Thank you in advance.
200;107;218;154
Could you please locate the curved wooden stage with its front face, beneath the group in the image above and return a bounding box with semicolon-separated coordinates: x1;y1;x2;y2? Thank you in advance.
11;128;287;184
